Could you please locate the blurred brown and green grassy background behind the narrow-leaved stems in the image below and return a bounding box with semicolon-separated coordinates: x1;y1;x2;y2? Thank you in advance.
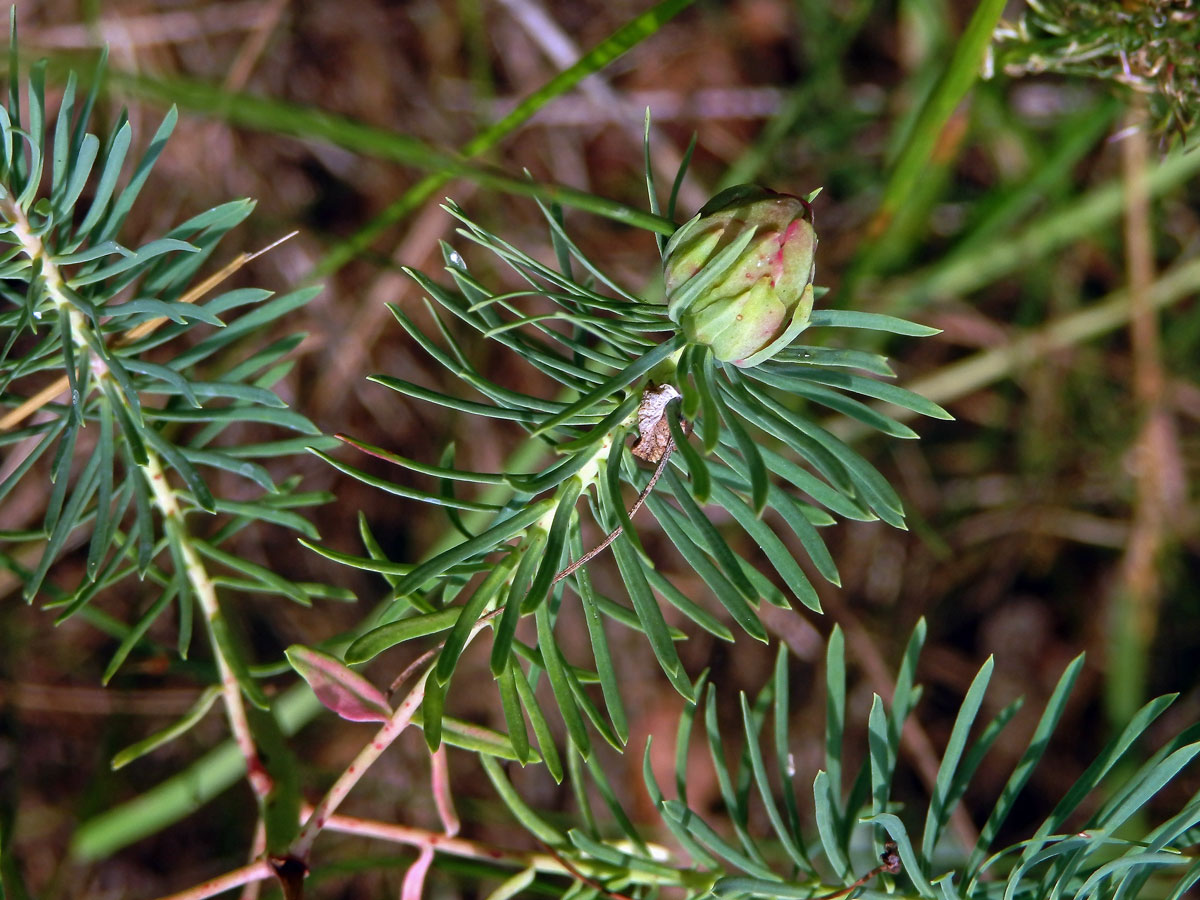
0;0;1200;898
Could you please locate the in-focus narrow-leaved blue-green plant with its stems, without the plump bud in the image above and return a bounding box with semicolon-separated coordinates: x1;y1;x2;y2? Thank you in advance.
0;4;1200;900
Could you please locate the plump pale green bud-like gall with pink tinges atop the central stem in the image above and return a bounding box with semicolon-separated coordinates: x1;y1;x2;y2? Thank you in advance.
662;185;817;367
